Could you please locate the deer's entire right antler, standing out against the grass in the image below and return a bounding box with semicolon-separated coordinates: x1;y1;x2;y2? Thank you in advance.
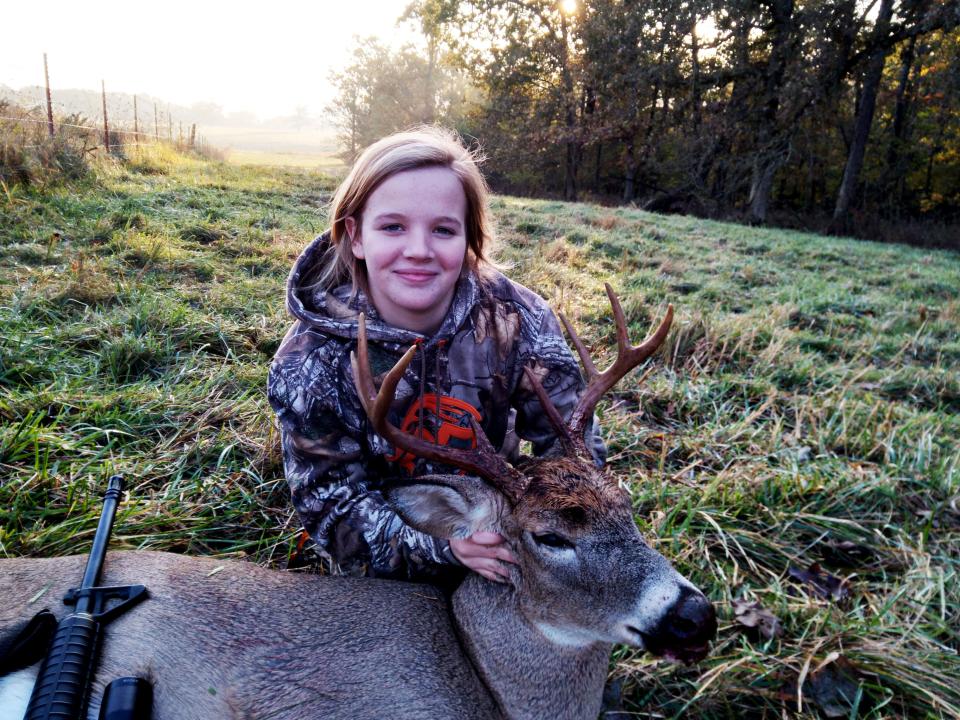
527;283;673;457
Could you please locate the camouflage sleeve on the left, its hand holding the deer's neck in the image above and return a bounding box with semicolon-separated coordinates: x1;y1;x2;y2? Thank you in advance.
268;334;459;580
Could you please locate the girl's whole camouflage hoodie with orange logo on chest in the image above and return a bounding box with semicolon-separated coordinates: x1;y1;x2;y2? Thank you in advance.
268;234;605;579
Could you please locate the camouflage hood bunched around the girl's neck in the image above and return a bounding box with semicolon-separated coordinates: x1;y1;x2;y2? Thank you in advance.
287;230;479;346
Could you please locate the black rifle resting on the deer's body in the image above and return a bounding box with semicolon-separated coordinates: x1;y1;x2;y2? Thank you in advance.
24;475;147;720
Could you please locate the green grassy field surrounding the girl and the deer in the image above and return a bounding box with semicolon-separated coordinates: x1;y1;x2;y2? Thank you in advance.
0;150;960;719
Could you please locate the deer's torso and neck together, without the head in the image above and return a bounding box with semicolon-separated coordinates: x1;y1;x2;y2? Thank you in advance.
0;540;688;720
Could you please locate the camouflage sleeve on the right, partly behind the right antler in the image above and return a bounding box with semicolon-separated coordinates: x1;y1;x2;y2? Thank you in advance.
514;308;607;466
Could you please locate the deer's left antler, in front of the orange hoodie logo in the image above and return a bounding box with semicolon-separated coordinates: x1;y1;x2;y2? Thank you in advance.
350;313;524;503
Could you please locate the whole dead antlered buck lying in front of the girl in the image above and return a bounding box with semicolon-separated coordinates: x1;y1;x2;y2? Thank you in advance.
0;286;716;720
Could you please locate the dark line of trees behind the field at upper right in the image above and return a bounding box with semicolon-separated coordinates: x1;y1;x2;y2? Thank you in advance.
333;0;960;245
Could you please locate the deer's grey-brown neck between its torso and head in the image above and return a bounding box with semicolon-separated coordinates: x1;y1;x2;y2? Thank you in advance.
452;573;612;720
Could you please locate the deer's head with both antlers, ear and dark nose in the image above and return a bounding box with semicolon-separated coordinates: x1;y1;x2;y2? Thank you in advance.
351;285;716;662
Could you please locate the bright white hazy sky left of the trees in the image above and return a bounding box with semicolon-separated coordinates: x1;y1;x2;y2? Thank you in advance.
0;0;417;118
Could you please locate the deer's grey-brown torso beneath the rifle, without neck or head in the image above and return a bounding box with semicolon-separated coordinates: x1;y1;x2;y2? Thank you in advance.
0;553;498;720
